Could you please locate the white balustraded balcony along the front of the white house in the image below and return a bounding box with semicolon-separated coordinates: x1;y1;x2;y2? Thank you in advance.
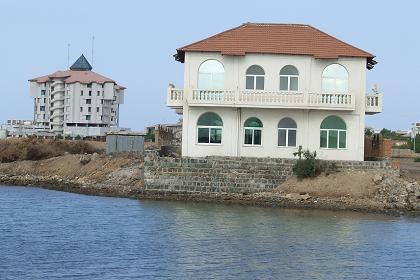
167;86;355;111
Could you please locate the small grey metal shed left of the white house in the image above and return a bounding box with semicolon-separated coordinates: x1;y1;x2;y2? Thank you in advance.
106;131;144;154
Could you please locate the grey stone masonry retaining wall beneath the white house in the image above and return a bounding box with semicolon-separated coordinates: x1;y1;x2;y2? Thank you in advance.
144;152;389;193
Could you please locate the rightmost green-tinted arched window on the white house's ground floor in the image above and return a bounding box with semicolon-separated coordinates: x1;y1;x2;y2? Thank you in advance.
320;116;347;149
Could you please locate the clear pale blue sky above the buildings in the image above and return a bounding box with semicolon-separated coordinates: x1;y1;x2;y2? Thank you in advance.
0;0;420;130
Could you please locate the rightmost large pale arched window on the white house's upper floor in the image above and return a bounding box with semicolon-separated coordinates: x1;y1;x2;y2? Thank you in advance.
322;63;349;93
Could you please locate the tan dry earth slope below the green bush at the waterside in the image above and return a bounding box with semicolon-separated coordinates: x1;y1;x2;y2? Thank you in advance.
275;171;376;199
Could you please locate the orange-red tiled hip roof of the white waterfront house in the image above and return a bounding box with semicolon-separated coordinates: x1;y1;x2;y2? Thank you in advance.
174;23;377;69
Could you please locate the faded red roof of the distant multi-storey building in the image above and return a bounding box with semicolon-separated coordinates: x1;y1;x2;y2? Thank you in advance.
29;70;125;90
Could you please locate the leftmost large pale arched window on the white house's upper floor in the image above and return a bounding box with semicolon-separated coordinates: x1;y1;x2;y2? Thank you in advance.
198;59;225;89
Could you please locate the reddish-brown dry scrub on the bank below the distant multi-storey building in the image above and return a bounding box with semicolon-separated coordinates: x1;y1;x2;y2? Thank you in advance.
0;138;104;162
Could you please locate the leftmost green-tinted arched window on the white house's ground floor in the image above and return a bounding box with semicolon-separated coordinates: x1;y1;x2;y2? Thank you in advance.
197;112;223;144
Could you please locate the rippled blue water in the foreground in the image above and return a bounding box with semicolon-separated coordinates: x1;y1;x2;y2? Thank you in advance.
0;187;420;280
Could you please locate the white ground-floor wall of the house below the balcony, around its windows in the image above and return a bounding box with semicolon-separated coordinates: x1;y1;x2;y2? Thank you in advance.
182;107;364;161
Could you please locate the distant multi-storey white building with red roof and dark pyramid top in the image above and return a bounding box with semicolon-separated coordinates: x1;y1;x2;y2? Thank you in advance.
29;55;125;137
